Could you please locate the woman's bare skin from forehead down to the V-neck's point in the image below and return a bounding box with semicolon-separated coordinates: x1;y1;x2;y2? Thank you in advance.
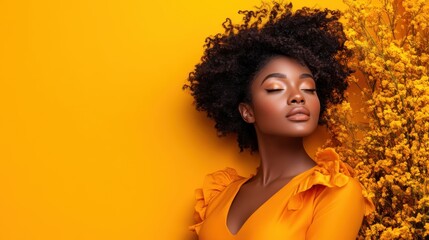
227;56;320;234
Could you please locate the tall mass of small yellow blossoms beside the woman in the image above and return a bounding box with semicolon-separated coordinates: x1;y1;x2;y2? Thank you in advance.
326;0;429;239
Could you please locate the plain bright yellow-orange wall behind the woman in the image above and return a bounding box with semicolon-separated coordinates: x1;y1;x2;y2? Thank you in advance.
0;0;343;240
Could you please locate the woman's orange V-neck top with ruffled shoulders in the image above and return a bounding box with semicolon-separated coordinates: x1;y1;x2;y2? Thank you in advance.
190;148;374;240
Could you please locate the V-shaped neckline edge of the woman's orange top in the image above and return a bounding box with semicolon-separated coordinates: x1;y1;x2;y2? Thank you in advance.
224;165;317;237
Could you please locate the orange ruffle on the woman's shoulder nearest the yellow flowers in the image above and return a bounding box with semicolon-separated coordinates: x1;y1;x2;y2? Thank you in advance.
287;148;375;215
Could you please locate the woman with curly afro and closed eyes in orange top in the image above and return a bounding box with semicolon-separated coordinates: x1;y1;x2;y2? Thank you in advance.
185;3;373;240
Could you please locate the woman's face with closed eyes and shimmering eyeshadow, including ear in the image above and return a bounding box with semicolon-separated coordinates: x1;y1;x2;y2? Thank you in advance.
239;56;320;137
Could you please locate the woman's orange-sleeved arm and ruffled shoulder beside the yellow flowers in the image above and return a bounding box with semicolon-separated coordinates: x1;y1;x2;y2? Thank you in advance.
306;149;374;239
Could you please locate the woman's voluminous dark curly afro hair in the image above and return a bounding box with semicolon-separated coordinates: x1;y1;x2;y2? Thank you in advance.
184;2;352;152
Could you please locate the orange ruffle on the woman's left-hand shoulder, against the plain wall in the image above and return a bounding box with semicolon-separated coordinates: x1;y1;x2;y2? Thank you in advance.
189;168;244;234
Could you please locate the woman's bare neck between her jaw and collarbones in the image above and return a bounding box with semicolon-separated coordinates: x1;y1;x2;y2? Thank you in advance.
255;134;316;185
